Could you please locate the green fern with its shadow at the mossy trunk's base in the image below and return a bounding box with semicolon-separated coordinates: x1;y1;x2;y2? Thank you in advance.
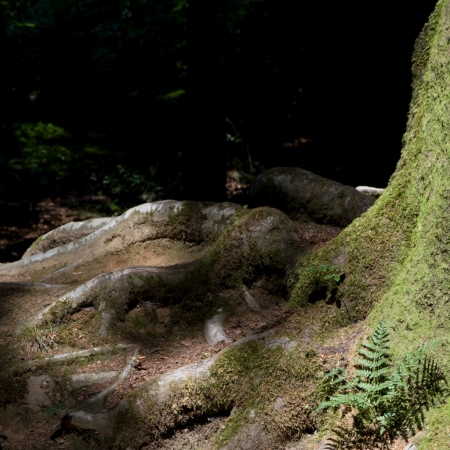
318;323;447;449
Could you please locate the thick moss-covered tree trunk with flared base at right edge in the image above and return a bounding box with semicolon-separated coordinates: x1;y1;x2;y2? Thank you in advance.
291;0;450;362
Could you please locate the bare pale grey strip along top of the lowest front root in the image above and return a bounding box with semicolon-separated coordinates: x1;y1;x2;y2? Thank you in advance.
61;331;295;432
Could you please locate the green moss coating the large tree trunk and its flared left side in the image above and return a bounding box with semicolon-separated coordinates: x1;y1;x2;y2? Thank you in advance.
290;1;450;332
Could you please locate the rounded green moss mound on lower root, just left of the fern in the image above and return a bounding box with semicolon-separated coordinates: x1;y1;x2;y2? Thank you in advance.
196;342;322;448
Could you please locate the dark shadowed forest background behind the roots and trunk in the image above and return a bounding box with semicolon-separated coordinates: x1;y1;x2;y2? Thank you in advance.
0;0;436;221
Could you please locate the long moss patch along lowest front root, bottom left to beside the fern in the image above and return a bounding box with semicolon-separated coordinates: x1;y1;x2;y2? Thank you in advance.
114;342;323;448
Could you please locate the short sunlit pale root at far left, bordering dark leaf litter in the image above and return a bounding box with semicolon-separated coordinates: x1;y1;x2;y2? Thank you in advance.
22;217;112;259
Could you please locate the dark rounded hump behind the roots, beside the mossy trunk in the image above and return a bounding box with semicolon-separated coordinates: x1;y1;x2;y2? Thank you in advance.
250;167;374;227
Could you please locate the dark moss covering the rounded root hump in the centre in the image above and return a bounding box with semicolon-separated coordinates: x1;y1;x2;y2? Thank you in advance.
107;206;293;326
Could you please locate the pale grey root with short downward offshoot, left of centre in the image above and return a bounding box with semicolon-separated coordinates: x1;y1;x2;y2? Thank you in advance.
16;262;196;334
